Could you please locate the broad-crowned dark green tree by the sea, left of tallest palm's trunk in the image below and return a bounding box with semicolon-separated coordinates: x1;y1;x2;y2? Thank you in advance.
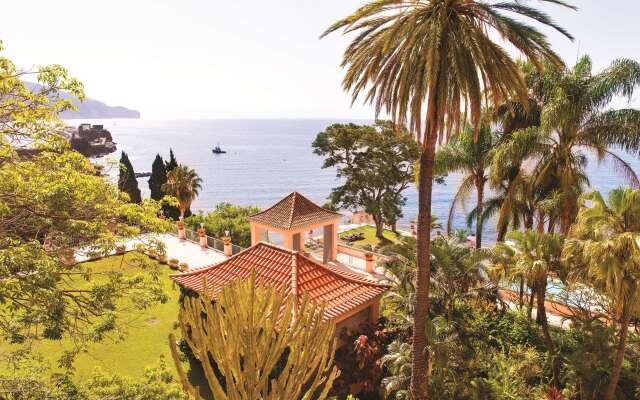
312;121;418;240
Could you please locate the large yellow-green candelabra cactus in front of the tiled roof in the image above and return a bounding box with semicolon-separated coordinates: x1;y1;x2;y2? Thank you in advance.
169;274;339;400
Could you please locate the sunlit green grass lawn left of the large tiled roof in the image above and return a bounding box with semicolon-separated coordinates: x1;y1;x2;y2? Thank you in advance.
11;254;185;381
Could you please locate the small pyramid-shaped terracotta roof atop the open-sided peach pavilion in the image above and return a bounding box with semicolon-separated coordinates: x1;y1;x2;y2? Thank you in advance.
249;192;342;230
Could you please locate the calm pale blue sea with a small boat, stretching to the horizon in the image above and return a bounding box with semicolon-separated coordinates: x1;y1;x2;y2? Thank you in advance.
79;119;640;241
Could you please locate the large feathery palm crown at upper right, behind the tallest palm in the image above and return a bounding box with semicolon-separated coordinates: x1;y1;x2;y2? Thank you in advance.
491;56;640;234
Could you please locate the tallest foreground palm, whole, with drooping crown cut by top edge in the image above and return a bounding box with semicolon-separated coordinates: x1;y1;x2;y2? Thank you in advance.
323;0;571;400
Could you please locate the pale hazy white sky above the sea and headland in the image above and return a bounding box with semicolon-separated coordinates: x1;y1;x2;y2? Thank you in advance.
0;0;640;118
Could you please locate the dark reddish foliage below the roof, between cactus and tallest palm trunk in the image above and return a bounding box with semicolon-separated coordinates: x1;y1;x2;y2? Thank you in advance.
331;323;393;400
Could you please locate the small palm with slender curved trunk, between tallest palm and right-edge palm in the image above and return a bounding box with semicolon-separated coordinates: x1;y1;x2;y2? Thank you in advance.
494;230;564;388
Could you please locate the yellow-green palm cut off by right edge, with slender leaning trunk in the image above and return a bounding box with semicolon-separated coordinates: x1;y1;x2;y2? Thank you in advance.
563;188;640;400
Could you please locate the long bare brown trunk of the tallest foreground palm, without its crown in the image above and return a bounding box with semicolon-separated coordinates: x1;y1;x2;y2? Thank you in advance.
410;141;435;400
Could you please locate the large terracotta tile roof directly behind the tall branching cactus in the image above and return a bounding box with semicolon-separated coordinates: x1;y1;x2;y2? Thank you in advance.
171;242;388;320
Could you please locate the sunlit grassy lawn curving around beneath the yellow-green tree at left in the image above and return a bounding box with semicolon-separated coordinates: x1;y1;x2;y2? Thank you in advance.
2;252;180;382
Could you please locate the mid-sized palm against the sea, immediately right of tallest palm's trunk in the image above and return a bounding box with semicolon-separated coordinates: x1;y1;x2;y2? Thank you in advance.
435;124;498;249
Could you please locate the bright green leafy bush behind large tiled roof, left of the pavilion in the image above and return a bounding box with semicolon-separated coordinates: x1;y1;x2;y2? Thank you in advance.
185;203;260;248
